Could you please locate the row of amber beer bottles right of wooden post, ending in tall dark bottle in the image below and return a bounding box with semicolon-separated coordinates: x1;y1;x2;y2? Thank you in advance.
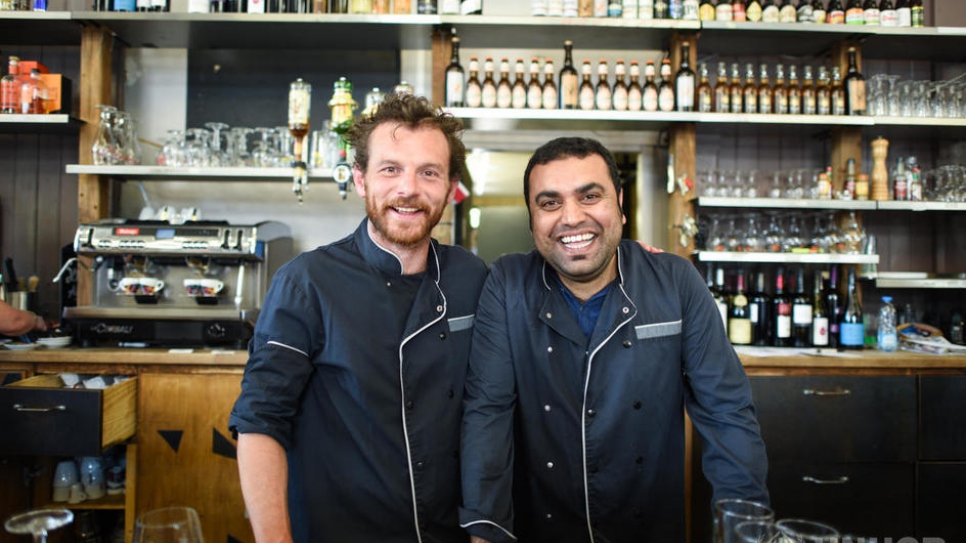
694;48;866;115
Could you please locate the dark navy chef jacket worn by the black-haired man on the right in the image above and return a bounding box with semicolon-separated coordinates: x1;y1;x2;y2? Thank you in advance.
460;240;768;543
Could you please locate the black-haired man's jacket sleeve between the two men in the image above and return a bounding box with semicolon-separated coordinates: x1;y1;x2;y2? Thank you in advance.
460;264;516;543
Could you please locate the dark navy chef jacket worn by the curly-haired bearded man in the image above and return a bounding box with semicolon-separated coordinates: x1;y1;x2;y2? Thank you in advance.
229;220;486;543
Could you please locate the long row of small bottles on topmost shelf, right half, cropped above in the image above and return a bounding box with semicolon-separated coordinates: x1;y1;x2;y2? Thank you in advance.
530;0;925;27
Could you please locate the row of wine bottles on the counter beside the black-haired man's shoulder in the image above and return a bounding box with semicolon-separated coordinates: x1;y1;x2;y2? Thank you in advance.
706;264;865;349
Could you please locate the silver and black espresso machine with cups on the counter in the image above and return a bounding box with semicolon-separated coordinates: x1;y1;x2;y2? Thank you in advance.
64;219;293;348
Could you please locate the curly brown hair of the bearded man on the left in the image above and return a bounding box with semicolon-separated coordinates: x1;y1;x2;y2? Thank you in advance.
346;93;466;181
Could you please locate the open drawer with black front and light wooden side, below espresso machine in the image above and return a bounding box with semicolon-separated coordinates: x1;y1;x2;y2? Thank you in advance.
0;374;137;456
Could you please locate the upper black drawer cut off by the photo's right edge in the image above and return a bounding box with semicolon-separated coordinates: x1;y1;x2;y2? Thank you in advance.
919;375;966;461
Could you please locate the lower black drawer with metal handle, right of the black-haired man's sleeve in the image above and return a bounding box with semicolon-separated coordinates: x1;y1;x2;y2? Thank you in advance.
768;463;916;541
